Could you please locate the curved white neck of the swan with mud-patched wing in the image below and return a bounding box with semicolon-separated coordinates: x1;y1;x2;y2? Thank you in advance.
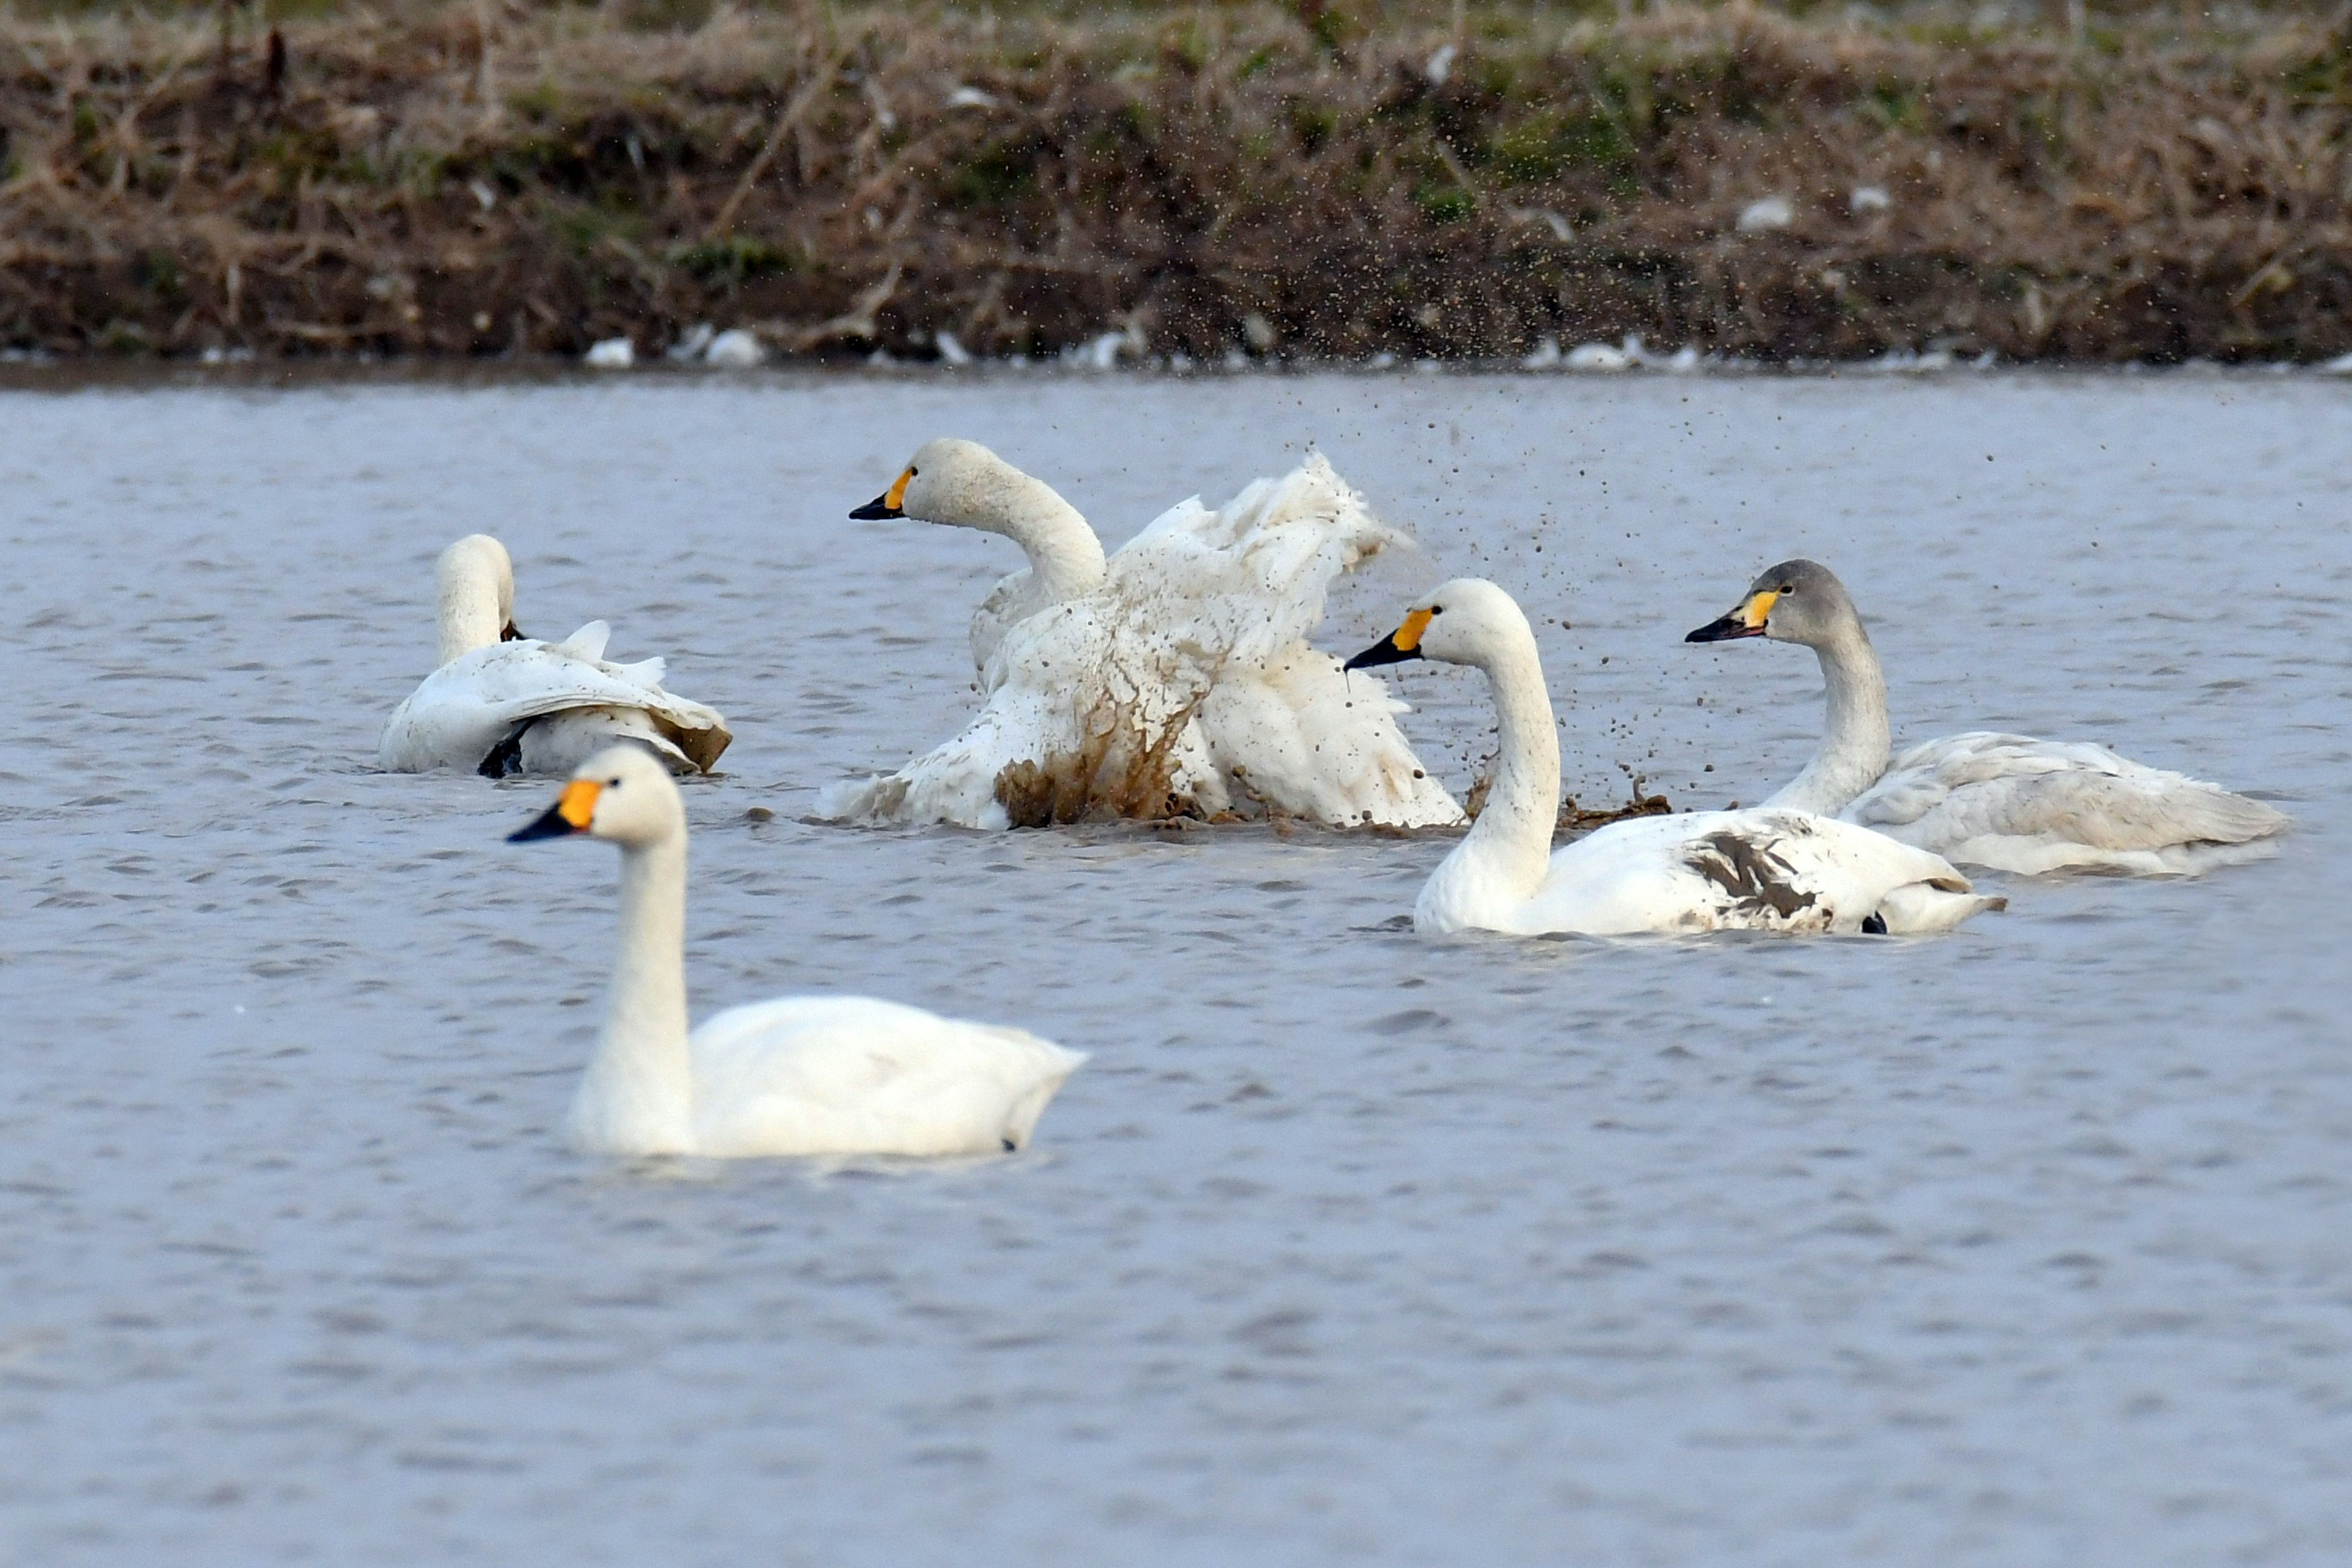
1420;637;1559;924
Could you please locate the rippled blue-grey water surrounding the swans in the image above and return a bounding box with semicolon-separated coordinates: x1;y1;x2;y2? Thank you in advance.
0;374;2352;1568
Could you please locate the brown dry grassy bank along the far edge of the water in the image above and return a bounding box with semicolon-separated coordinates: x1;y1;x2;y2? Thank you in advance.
0;0;2352;360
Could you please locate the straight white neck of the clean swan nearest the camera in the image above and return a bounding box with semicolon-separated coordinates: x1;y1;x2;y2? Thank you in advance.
571;832;694;1154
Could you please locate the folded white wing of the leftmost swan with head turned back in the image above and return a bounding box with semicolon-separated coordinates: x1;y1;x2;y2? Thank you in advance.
376;639;731;774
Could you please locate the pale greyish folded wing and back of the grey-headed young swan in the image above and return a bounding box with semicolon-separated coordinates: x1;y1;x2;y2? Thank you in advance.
1842;731;2288;875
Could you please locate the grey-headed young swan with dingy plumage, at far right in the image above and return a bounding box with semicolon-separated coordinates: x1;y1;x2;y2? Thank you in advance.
1686;559;2288;877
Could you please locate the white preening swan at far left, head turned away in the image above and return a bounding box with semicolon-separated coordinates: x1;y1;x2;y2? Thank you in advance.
376;533;731;778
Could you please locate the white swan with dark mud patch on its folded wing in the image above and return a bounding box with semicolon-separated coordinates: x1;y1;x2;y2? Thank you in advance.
1348;578;2004;936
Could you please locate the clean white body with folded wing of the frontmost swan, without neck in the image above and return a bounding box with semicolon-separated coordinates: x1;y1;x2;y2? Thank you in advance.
689;997;1087;1159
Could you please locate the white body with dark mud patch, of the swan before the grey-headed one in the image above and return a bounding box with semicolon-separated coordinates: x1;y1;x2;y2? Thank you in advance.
1510;809;1999;936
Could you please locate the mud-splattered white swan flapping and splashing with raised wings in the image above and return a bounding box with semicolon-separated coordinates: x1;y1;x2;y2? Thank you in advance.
818;440;1463;827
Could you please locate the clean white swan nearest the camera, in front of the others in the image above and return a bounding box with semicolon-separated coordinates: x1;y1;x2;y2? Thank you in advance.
508;745;1087;1159
